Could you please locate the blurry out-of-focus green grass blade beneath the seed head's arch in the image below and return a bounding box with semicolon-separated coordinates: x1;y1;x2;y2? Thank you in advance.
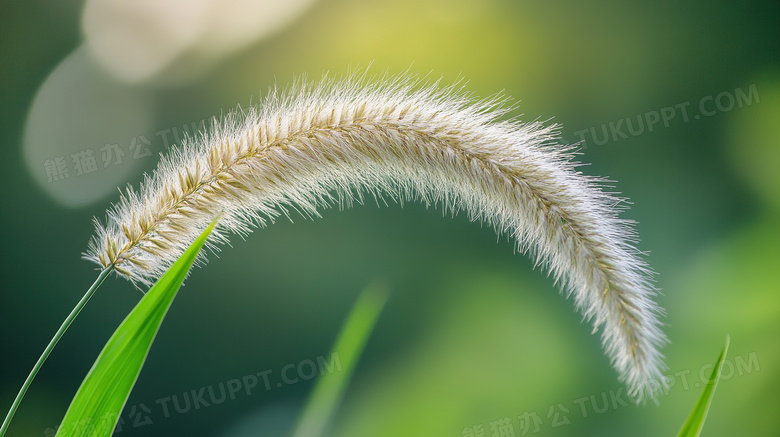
293;284;388;437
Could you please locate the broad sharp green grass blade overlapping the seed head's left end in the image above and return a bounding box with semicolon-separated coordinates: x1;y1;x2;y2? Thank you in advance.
57;221;216;437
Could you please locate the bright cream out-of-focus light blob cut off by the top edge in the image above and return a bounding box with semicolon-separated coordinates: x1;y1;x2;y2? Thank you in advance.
82;0;315;85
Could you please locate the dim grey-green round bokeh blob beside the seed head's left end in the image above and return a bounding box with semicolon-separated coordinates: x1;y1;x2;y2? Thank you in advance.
22;47;156;207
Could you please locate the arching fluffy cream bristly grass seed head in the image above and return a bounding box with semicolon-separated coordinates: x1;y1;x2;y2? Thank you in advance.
85;73;666;398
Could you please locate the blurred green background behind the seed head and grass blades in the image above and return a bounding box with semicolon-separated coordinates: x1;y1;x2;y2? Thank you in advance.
0;0;780;437
